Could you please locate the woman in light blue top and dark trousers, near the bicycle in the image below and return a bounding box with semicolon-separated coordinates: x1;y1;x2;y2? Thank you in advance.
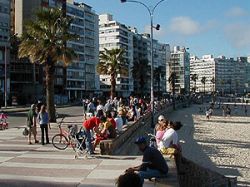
37;105;51;145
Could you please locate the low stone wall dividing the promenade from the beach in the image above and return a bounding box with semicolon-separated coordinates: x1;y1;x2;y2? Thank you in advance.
100;103;237;187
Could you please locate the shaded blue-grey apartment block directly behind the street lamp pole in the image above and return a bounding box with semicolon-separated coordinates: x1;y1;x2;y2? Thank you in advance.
130;28;170;96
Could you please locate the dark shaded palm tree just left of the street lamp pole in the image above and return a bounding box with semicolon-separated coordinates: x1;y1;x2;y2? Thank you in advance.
132;59;150;96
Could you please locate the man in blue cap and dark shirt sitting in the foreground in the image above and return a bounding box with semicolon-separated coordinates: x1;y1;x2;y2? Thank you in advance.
126;136;168;183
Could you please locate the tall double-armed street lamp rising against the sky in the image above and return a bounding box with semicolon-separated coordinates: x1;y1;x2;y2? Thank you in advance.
121;0;165;127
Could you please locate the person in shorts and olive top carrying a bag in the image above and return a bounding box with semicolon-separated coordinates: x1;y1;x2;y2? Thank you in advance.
27;104;39;144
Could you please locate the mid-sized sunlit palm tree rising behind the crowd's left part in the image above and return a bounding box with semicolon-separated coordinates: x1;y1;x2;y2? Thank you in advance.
96;48;128;99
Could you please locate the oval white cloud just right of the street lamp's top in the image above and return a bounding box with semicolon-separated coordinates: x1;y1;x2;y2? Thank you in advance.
169;16;201;35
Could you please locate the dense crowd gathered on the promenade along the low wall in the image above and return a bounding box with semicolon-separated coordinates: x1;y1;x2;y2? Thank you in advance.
82;96;182;154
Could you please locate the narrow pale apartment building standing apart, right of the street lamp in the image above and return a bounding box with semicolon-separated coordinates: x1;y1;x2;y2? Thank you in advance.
167;46;190;93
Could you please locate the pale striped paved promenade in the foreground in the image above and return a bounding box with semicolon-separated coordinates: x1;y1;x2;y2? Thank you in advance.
0;121;156;187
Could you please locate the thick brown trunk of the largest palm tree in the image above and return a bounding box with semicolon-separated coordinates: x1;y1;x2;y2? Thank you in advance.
45;57;56;122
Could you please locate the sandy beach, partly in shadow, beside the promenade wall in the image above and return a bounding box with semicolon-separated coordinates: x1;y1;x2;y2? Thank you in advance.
167;104;250;186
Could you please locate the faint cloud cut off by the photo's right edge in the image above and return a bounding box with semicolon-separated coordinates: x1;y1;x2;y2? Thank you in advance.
224;23;250;48
